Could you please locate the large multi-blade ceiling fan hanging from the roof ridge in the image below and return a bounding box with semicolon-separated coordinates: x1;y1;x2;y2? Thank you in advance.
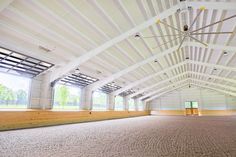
134;7;236;51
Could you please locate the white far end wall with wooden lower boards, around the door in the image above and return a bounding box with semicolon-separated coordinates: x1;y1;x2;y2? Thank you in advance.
149;87;236;115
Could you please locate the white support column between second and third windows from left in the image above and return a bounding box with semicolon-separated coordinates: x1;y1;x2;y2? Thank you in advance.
80;87;93;110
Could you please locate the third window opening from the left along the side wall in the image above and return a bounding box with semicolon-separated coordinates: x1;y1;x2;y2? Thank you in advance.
92;92;107;110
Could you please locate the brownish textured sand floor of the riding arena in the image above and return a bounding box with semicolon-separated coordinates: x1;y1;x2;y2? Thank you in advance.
0;116;236;157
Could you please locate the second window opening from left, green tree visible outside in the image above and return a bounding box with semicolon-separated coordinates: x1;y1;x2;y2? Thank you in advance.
53;84;81;110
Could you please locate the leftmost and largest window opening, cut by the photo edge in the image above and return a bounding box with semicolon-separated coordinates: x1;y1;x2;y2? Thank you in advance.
0;73;31;108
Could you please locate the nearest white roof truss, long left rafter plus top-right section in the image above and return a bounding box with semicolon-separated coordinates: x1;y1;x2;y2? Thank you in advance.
50;2;236;82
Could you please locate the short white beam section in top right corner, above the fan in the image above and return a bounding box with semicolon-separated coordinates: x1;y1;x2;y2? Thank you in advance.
187;1;236;10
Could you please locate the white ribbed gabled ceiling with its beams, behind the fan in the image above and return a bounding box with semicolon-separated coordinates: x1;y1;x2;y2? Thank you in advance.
0;0;236;100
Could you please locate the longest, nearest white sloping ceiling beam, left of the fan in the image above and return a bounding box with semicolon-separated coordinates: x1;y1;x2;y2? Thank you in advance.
50;5;179;82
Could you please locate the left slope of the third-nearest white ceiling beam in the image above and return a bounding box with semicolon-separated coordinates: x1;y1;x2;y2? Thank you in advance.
112;61;186;95
